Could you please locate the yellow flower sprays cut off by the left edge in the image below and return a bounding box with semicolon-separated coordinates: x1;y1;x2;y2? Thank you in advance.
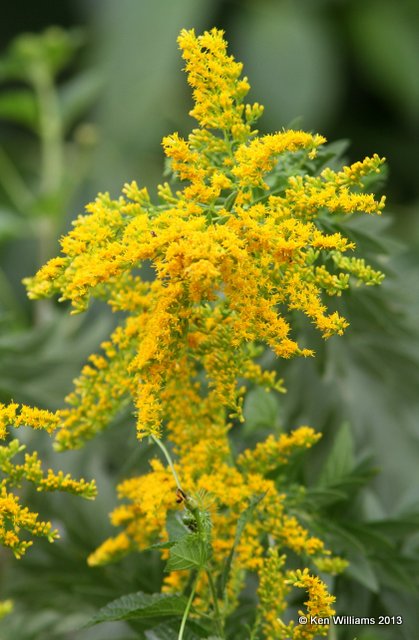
0;410;96;558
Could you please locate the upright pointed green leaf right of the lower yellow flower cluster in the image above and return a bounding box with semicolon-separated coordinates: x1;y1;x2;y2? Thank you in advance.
318;423;354;487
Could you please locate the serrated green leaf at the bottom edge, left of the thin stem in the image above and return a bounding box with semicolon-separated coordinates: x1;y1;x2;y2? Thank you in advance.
84;591;187;627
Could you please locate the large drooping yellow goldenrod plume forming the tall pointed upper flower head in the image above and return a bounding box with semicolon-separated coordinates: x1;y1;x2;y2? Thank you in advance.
19;29;384;448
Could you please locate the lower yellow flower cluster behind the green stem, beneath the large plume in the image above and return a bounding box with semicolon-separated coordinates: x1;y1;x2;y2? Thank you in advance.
89;370;346;624
